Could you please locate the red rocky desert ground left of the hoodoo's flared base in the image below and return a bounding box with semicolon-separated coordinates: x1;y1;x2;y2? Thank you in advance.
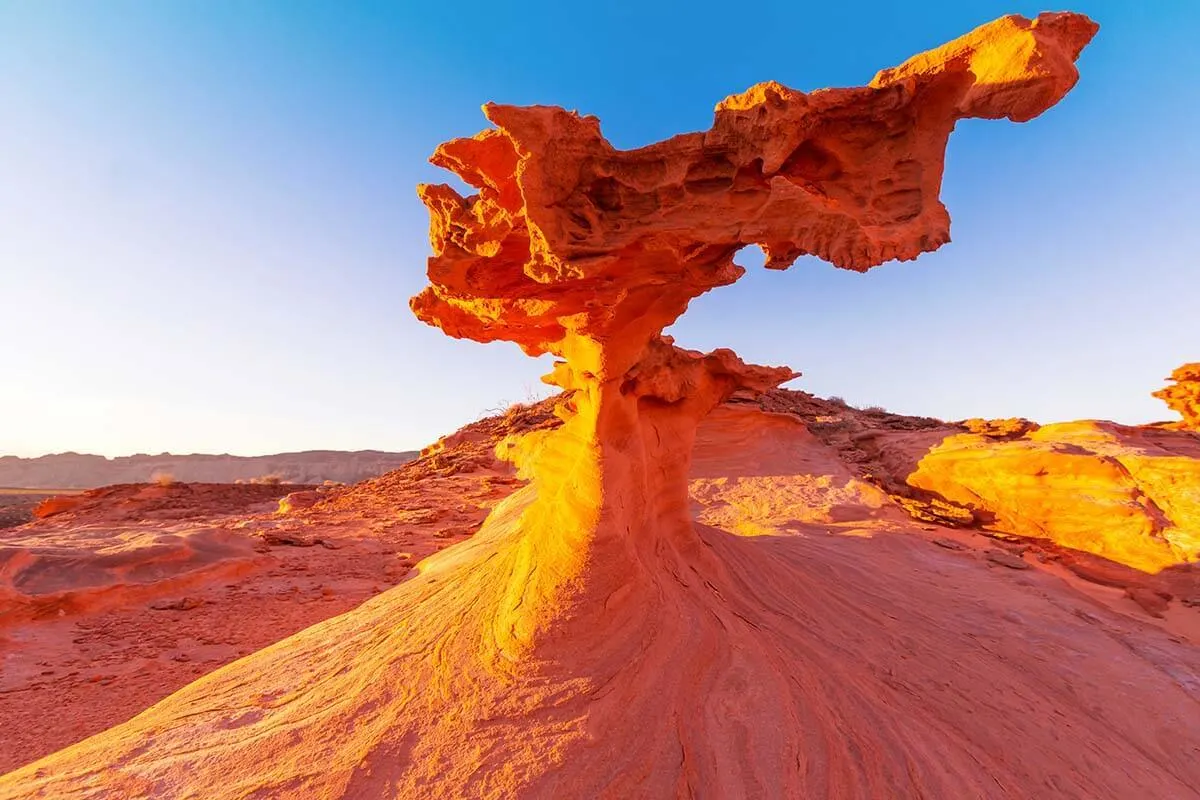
0;475;503;772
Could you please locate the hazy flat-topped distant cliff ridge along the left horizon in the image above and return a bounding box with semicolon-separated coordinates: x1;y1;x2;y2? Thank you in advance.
0;450;418;489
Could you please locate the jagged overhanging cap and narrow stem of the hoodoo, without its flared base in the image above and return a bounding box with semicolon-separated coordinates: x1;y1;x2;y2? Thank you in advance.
412;13;1097;646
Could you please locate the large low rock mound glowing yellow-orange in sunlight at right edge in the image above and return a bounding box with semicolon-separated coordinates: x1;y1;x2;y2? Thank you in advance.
907;422;1200;572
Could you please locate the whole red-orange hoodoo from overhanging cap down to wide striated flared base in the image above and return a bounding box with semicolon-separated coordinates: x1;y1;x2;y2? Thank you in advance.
0;13;1132;798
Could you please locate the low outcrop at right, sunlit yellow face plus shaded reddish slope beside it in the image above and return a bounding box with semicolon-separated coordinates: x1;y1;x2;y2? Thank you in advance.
760;390;1200;575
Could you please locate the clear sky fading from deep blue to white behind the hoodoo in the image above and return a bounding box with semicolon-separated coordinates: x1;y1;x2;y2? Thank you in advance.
0;0;1200;456
